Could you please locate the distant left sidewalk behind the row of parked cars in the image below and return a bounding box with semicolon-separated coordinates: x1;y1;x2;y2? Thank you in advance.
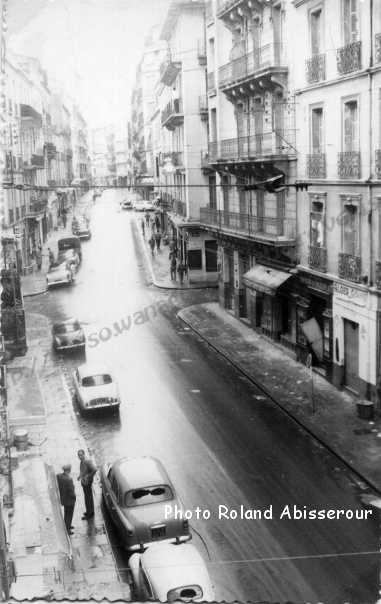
21;191;93;298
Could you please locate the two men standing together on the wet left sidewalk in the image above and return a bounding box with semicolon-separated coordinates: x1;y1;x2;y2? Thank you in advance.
57;449;97;535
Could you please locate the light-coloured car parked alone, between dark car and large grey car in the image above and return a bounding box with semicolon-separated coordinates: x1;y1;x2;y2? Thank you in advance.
73;363;120;412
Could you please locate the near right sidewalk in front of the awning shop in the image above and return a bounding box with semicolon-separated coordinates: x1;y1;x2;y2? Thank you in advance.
178;303;381;493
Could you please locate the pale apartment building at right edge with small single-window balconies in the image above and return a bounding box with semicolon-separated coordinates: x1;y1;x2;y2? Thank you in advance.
294;0;381;398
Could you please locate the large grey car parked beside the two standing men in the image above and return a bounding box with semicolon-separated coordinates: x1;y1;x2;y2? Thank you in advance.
101;457;191;552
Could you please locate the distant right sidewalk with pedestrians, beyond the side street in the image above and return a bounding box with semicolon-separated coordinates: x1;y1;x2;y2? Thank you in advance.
134;212;217;289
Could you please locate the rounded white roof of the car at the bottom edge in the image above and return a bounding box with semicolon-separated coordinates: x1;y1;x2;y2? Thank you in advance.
141;543;210;601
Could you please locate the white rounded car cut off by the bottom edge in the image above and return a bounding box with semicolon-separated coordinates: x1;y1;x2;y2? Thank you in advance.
128;543;215;602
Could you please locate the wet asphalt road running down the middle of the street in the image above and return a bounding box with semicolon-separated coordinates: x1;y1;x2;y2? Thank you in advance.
26;192;380;604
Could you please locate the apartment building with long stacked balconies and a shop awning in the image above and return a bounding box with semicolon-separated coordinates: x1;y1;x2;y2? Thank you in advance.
200;0;297;330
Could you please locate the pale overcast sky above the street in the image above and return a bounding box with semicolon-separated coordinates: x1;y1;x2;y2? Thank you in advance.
8;0;169;128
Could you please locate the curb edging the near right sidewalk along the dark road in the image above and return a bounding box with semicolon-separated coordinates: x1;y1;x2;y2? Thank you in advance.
176;307;381;496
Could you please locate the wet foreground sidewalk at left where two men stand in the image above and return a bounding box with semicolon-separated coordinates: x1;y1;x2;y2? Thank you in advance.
8;314;129;600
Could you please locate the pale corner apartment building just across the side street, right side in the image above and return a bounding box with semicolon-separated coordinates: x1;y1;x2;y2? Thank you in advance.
158;0;218;283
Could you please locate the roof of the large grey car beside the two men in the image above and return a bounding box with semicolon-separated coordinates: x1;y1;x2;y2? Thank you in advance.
112;457;172;491
